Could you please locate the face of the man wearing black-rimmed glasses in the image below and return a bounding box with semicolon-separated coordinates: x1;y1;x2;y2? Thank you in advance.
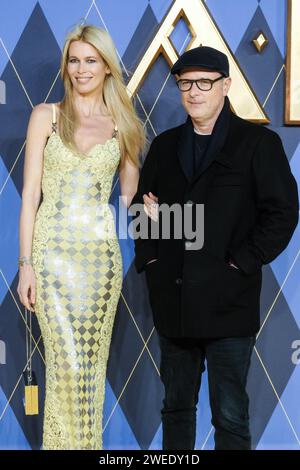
177;68;231;123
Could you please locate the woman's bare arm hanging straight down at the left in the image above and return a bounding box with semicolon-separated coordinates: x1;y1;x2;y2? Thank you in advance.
17;103;51;312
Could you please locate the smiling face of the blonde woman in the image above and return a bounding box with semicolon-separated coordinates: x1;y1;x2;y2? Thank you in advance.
67;41;110;95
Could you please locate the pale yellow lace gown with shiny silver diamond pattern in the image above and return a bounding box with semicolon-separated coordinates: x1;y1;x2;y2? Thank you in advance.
32;106;122;450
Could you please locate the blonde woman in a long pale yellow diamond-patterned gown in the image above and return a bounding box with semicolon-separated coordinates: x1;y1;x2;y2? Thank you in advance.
18;25;145;450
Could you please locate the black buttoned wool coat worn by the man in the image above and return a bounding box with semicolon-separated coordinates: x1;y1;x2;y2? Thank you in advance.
132;98;299;338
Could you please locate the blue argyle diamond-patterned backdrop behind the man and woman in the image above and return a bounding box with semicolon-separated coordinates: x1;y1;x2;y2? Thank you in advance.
0;0;300;450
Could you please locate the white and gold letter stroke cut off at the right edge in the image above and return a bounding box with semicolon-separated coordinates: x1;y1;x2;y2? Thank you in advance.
285;0;300;126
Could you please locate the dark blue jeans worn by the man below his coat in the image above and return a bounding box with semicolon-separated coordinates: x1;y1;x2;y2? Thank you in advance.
159;336;255;450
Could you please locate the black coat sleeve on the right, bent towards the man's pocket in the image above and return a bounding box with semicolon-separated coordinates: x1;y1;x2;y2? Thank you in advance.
230;132;299;274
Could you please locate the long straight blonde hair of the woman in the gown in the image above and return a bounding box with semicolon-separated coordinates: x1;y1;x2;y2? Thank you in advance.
59;25;146;167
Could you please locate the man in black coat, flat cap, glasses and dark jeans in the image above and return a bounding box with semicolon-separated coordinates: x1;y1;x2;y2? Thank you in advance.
132;47;299;449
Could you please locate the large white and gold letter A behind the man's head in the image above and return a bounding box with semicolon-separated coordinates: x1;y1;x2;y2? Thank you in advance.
128;0;269;123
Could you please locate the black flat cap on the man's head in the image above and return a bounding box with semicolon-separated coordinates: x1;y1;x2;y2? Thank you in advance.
171;46;229;77
